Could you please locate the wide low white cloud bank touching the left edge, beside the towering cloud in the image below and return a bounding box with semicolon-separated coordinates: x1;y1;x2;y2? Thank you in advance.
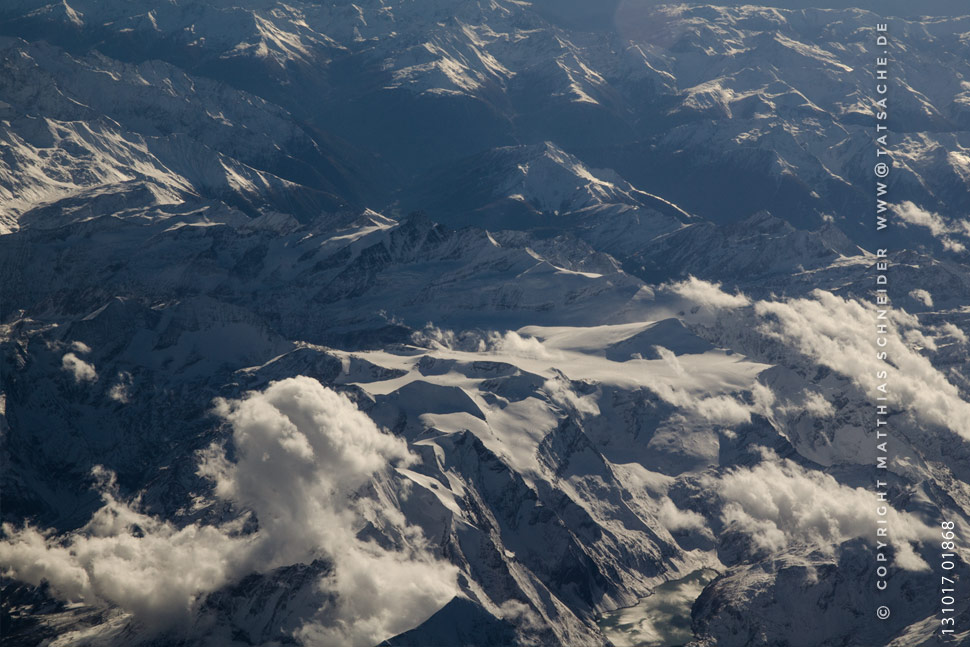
0;468;250;626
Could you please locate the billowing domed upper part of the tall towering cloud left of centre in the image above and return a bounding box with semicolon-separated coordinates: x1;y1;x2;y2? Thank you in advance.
199;377;409;566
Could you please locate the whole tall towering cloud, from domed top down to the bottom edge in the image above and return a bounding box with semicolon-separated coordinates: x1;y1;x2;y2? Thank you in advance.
200;377;457;646
